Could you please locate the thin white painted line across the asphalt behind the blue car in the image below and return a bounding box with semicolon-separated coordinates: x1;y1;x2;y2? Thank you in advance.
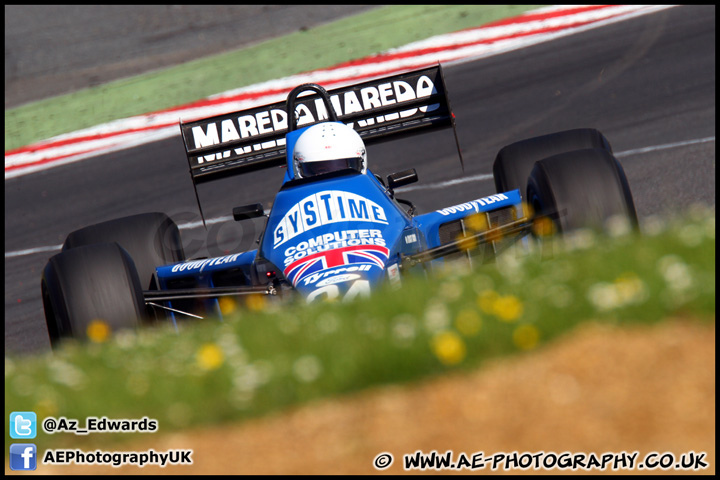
5;137;715;259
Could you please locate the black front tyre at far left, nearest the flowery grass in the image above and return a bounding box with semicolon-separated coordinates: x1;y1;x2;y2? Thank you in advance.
41;243;146;347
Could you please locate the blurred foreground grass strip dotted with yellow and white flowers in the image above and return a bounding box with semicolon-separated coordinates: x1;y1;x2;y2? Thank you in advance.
5;207;715;449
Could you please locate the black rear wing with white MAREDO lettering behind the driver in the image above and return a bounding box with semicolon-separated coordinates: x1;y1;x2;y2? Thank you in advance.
180;64;463;188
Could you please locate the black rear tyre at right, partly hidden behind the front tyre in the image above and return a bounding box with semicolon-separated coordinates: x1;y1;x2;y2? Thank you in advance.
493;128;612;196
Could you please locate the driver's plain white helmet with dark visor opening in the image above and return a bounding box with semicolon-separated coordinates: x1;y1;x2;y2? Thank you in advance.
293;122;367;178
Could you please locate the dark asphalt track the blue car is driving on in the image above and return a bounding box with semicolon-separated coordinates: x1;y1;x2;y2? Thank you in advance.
5;6;715;353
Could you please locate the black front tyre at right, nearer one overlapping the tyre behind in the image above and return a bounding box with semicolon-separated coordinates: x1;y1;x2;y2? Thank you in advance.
527;149;638;233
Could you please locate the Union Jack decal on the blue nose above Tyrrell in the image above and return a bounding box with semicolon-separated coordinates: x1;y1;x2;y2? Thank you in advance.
283;245;390;286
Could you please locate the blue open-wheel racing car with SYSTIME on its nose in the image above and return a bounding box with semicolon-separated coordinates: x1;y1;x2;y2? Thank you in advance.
41;64;637;346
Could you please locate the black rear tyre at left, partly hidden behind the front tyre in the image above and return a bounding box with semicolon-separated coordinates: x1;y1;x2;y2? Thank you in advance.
63;212;185;290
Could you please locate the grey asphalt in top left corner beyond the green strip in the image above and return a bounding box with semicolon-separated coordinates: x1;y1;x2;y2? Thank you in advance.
5;5;374;108
